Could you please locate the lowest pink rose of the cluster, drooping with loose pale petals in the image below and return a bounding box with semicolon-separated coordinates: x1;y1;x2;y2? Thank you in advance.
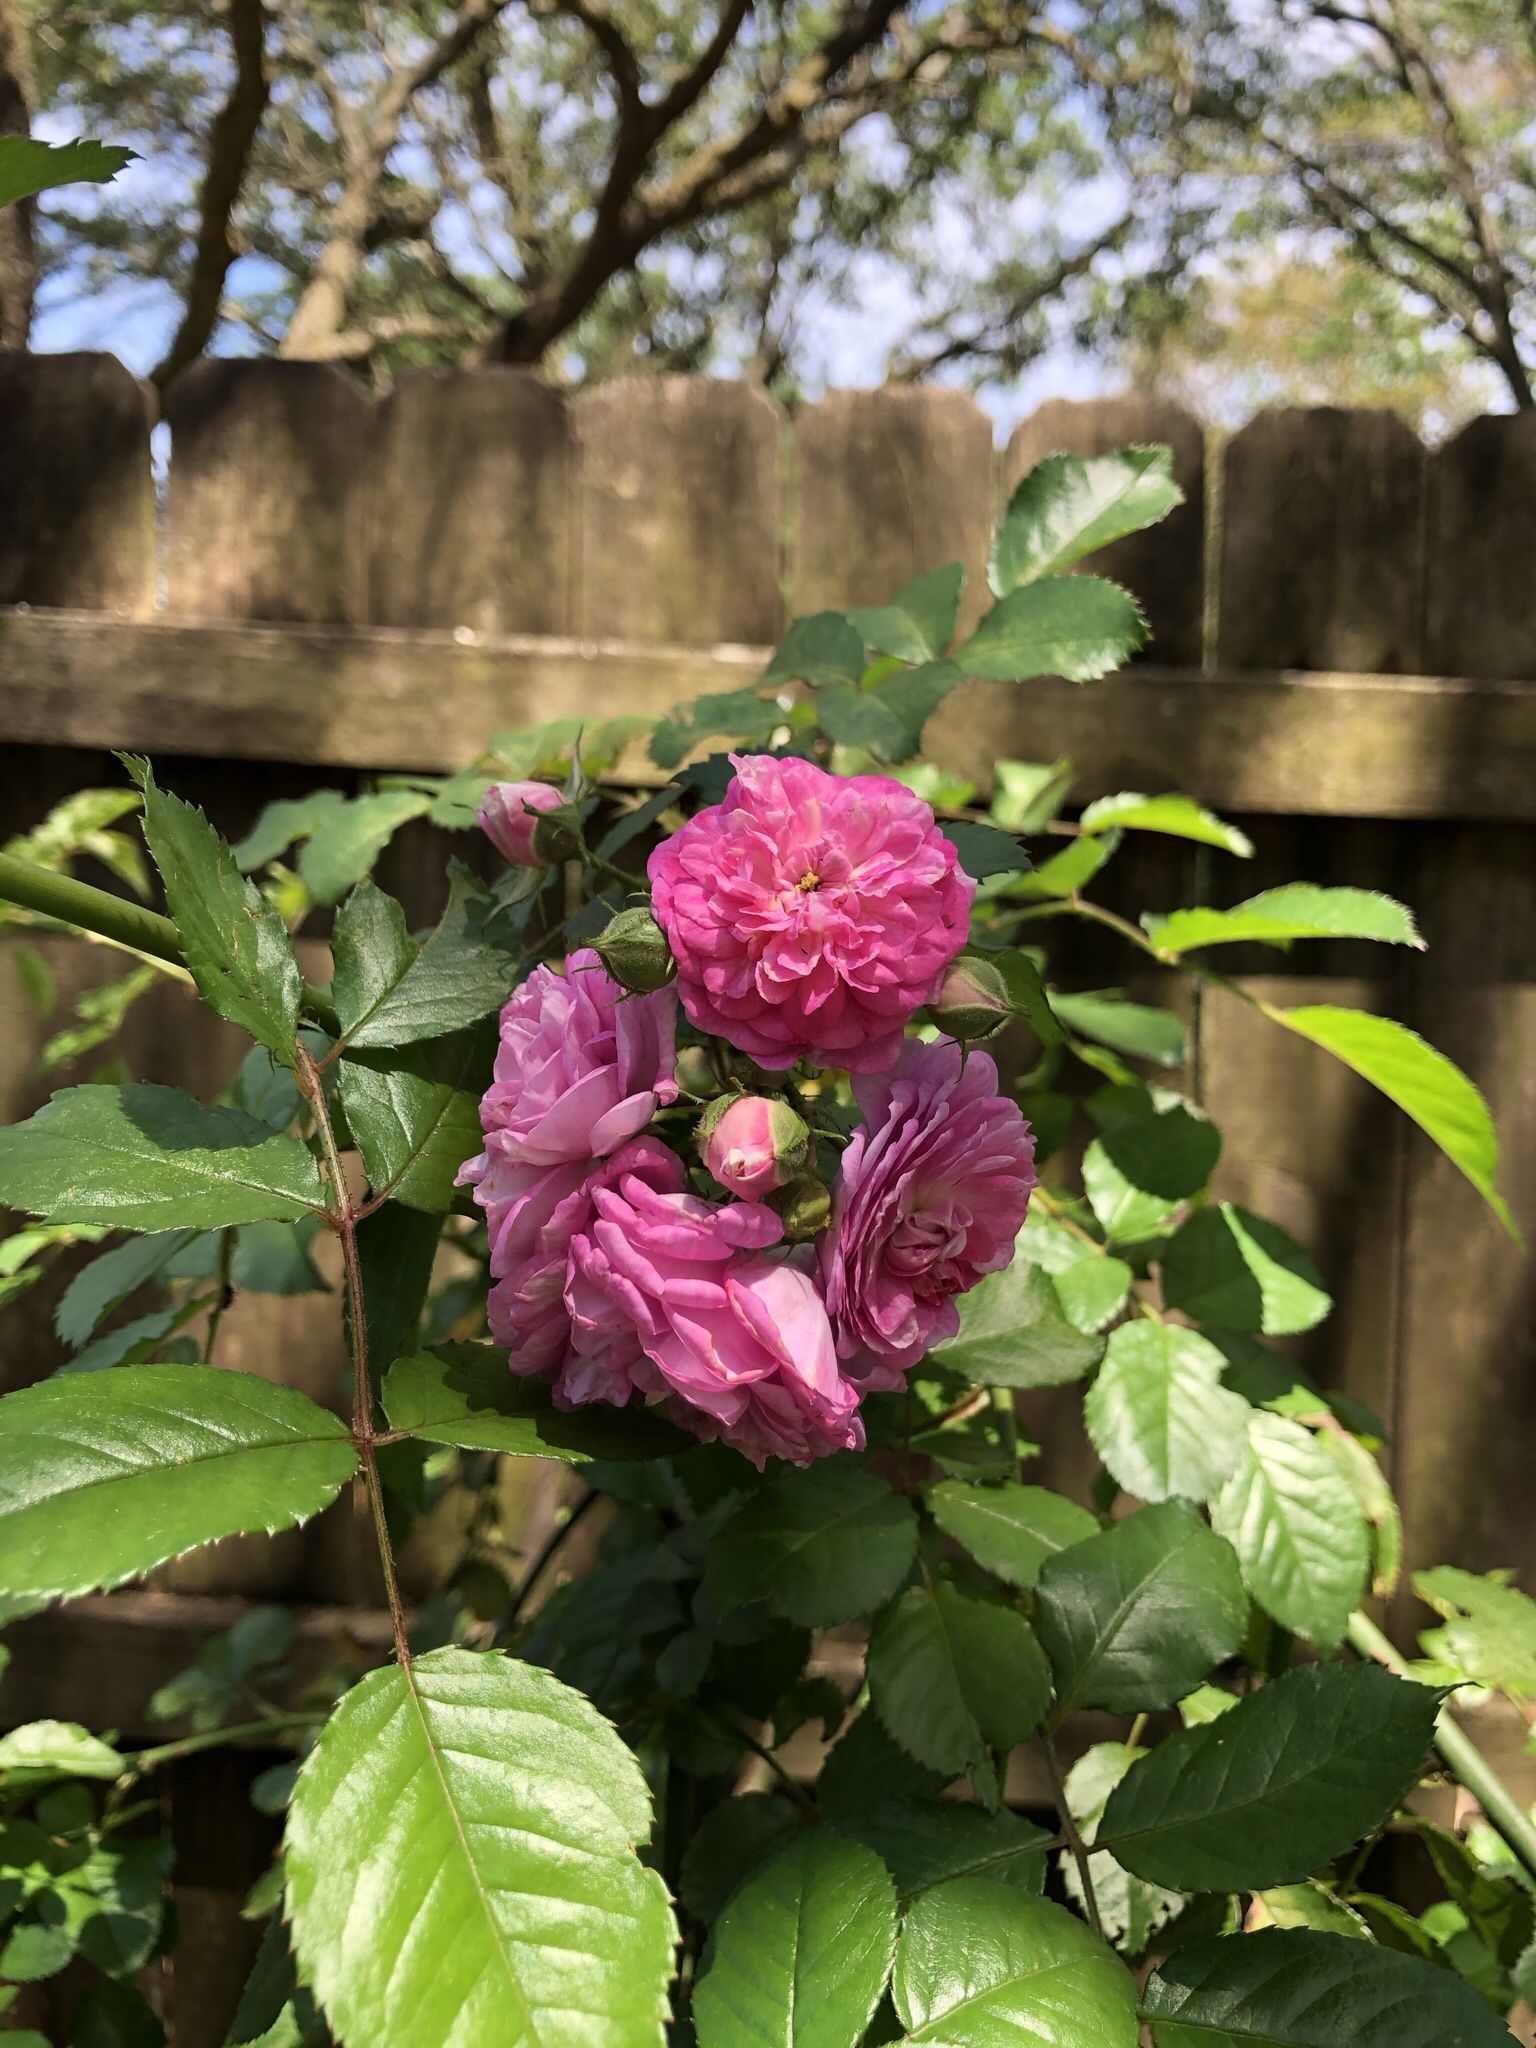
565;1174;864;1470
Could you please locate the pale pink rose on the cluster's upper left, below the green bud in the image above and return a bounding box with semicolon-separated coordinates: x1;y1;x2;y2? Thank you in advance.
459;946;678;1171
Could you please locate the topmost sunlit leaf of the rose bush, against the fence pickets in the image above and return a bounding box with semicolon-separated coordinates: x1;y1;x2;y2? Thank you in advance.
989;446;1184;596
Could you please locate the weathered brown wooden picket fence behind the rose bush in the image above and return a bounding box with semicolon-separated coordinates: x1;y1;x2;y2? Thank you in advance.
0;354;1536;2048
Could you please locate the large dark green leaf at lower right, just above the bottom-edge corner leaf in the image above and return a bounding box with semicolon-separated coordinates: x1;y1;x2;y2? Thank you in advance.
1098;1663;1440;1892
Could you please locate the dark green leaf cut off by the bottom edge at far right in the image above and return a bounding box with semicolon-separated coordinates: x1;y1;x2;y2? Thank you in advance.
1141;1927;1509;2048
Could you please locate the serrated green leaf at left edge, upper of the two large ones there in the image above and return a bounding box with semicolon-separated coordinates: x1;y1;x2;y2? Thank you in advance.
0;1081;326;1231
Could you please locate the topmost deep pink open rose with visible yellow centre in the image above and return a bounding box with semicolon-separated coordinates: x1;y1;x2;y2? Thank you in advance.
649;754;975;1073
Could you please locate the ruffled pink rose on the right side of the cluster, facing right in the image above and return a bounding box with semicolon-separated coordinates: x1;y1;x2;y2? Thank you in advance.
821;1038;1034;1389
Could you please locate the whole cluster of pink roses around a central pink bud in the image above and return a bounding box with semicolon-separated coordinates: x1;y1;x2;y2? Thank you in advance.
461;756;1034;1466
